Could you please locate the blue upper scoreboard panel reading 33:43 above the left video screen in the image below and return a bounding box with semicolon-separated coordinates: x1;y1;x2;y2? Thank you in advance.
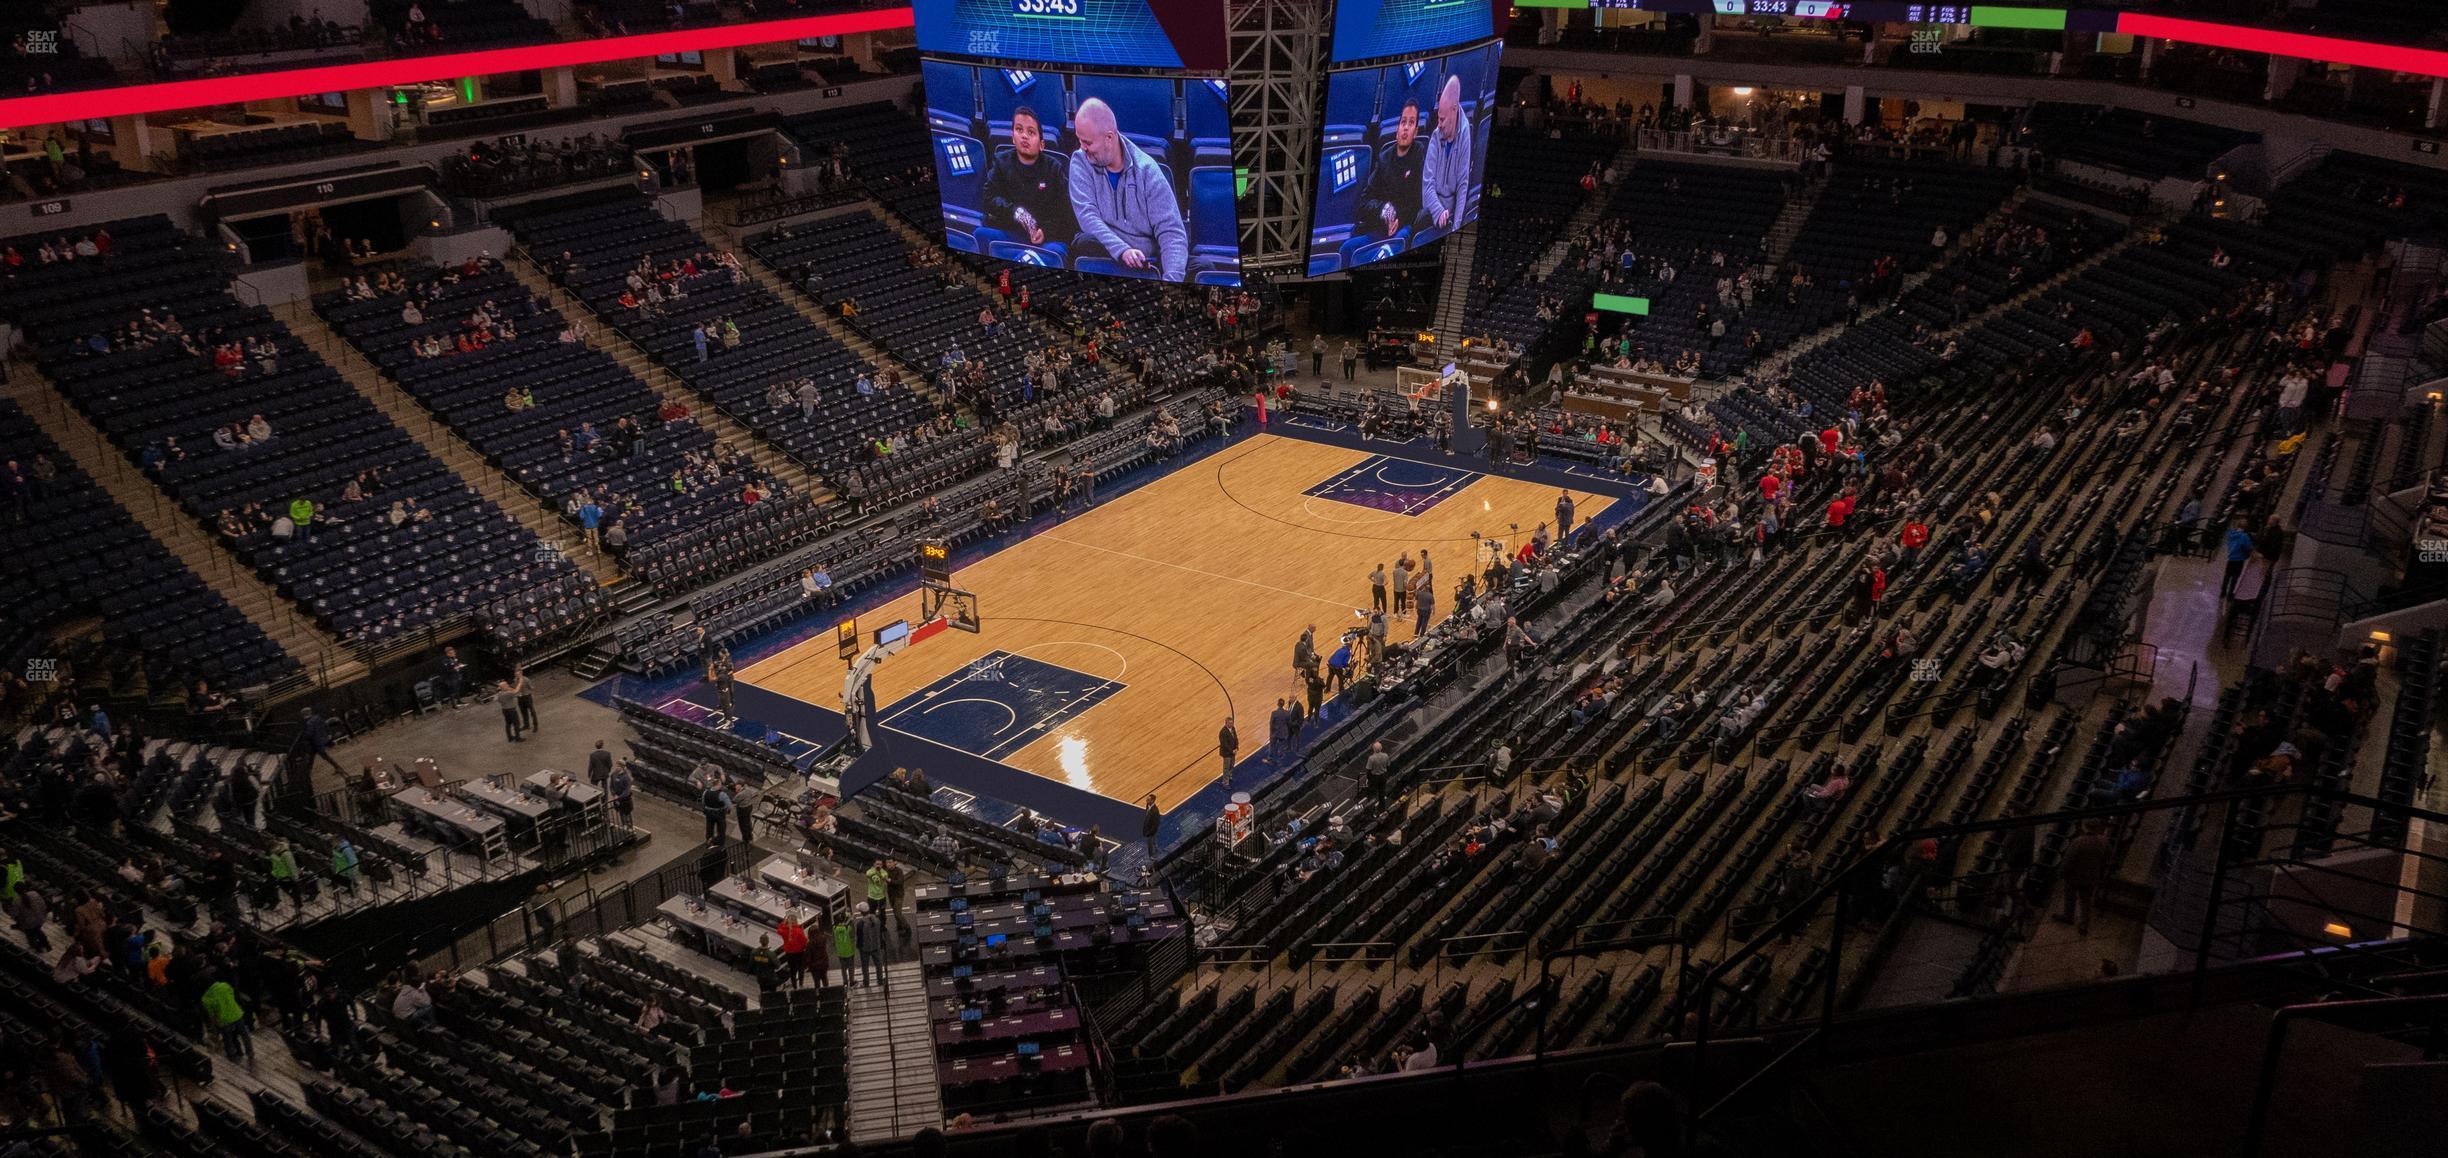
911;0;1224;71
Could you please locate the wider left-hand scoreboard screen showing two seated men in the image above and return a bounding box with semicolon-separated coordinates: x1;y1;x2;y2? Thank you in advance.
925;61;1241;286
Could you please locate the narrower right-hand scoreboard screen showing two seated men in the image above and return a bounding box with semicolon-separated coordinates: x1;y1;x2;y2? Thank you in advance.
1310;42;1503;277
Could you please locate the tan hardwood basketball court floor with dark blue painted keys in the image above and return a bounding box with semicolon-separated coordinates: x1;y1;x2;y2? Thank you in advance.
739;436;1611;810
